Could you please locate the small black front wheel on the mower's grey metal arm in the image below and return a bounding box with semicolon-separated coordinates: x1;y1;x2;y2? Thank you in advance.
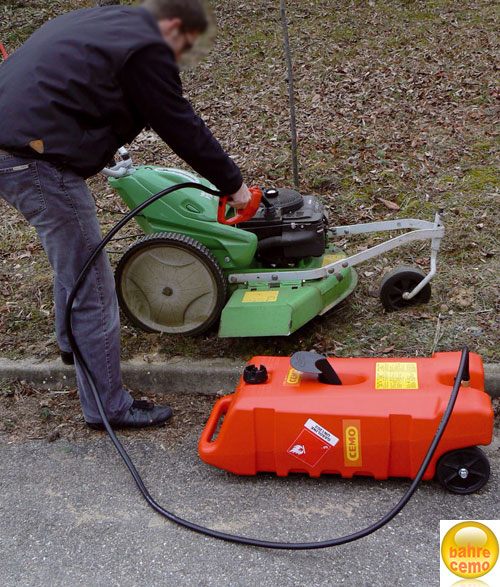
379;267;431;312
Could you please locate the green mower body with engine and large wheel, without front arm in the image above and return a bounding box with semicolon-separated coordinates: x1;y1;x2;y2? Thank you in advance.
108;166;357;337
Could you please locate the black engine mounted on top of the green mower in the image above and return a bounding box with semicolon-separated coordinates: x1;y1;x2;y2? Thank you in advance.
238;188;328;267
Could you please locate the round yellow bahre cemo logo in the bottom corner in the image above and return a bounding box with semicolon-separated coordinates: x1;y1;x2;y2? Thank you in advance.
441;522;498;579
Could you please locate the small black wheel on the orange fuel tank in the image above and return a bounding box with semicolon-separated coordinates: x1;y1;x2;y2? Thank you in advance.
435;446;490;494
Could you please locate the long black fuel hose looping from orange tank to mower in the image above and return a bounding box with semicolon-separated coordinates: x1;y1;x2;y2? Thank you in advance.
65;182;469;550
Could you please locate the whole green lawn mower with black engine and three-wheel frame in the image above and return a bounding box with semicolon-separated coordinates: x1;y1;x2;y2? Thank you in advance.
102;149;444;337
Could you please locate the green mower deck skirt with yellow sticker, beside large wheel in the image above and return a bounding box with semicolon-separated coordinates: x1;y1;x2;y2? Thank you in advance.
219;269;358;338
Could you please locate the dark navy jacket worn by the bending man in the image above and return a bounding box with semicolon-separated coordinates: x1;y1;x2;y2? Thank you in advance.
0;6;242;194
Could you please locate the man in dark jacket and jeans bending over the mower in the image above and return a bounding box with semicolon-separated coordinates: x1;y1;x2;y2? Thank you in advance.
0;0;250;429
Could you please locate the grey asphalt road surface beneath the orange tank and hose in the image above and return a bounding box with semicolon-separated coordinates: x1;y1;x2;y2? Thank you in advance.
0;428;500;587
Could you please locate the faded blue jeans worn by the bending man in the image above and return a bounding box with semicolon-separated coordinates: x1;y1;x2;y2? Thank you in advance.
0;153;132;423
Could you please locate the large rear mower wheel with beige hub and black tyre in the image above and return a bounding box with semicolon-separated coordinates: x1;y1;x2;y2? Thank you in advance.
115;232;227;335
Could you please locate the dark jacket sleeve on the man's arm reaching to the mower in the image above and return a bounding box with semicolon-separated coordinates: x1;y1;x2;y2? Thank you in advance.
120;44;243;195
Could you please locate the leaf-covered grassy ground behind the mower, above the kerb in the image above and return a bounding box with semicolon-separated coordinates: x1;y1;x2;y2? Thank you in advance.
0;0;500;362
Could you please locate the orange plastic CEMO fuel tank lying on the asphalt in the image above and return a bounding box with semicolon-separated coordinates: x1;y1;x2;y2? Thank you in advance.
199;352;493;479
